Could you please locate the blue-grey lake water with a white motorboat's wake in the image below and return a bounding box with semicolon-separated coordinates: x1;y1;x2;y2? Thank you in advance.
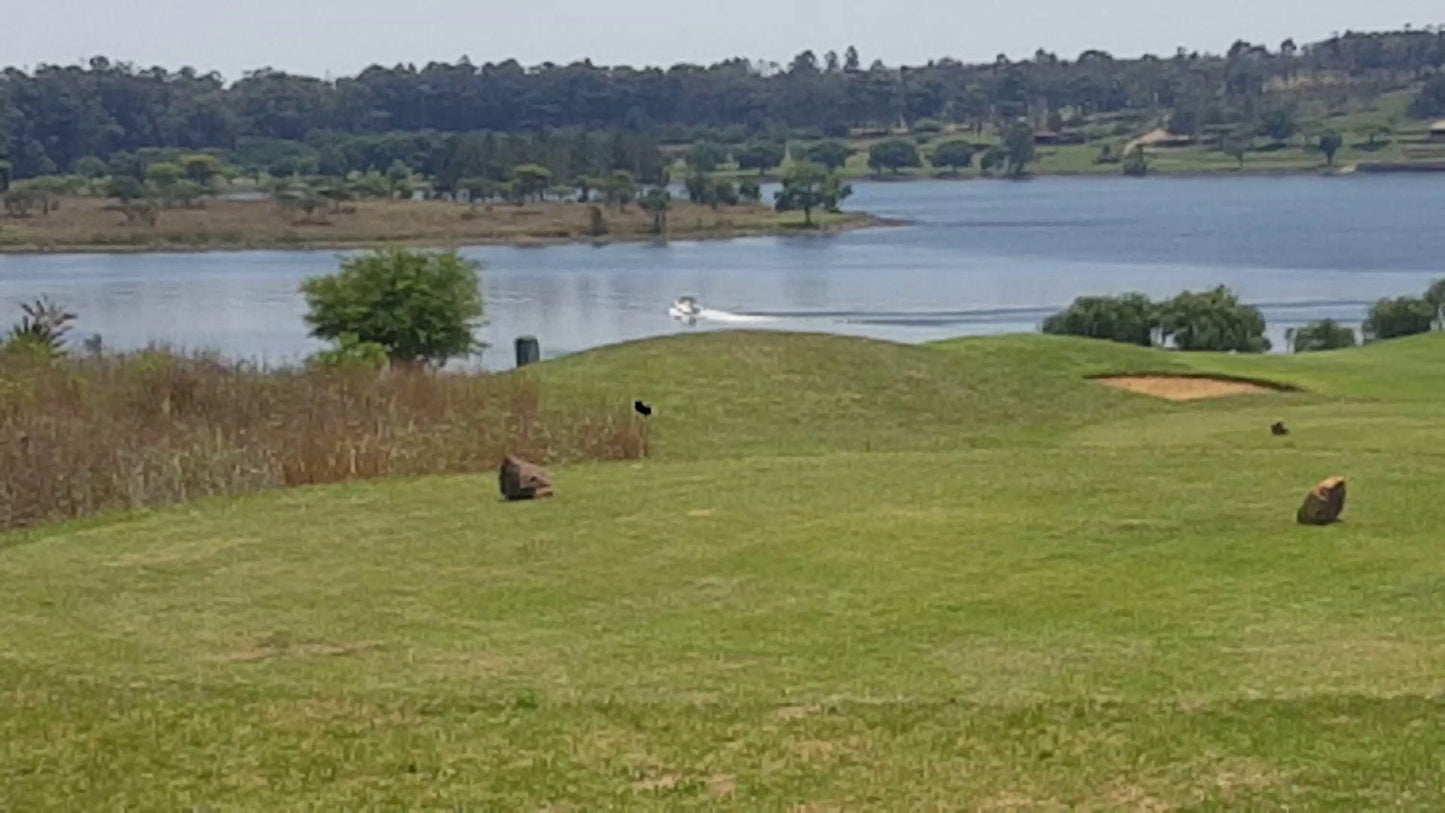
0;175;1445;368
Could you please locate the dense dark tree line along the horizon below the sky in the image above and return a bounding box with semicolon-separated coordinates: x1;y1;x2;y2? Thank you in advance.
0;29;1445;178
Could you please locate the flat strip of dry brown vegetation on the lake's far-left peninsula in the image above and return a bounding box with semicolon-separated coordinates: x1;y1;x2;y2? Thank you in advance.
0;198;867;251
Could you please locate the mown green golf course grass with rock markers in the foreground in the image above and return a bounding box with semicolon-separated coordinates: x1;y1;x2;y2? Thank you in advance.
0;332;1445;810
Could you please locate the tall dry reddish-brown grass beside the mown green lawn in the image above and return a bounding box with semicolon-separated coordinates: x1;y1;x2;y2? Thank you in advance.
0;351;646;530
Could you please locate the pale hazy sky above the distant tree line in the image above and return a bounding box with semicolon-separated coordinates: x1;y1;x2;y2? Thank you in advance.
11;0;1445;78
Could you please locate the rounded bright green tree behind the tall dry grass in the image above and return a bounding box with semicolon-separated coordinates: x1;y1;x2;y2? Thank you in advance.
301;248;483;367
